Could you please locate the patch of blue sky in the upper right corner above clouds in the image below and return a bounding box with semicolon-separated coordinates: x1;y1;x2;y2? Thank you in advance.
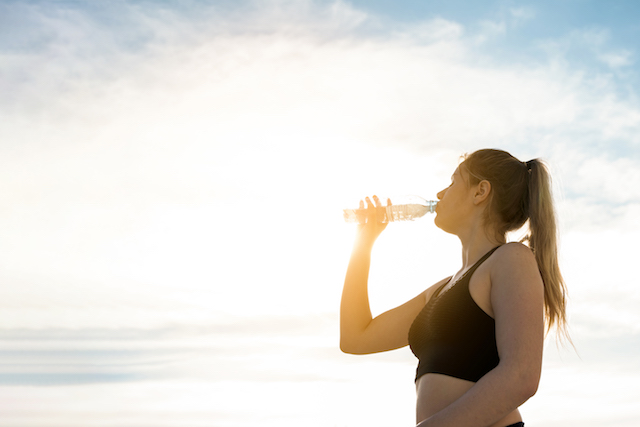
352;0;640;95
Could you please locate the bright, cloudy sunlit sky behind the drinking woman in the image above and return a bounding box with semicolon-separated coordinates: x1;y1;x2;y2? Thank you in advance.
0;0;640;427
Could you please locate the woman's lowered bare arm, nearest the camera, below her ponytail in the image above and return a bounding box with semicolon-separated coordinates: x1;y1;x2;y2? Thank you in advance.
418;243;544;427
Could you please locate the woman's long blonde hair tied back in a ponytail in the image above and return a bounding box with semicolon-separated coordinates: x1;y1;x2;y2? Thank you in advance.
461;149;571;341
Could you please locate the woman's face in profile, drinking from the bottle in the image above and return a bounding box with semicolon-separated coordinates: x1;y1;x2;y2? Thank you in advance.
434;167;473;234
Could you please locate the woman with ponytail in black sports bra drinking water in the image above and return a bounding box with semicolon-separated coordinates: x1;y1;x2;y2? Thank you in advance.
340;150;566;427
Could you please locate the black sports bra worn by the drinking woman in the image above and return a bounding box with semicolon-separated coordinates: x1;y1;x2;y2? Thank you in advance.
409;247;500;382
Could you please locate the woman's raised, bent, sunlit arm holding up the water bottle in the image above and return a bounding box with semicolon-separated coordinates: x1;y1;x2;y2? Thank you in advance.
340;198;444;354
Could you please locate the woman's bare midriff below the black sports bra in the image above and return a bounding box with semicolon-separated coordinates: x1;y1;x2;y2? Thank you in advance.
416;374;522;427
